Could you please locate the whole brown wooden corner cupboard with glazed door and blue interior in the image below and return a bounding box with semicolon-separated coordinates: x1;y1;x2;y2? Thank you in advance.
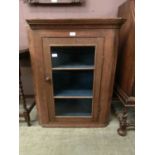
27;18;125;127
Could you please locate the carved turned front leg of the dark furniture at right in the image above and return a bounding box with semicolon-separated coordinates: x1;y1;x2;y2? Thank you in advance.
117;107;128;136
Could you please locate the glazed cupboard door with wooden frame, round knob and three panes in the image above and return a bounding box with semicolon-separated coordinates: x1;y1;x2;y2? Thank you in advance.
43;38;104;123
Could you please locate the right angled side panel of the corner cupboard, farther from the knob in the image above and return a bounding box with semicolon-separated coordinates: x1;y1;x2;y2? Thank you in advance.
99;30;119;124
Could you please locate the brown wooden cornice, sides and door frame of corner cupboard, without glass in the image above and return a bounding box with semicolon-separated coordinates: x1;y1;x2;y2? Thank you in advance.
27;18;125;127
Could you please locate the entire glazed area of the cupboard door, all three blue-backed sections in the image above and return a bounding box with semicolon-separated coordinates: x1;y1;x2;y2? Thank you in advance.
51;46;95;116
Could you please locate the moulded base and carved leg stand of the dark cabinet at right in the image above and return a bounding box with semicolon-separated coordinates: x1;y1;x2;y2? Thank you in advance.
112;87;135;136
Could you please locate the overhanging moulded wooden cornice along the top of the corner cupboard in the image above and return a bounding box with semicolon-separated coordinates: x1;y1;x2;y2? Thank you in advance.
26;18;126;29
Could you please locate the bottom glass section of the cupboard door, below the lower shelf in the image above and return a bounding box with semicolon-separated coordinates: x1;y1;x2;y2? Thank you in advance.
55;99;92;116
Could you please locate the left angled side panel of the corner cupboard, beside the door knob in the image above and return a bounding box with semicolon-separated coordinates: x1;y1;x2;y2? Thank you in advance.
29;30;49;124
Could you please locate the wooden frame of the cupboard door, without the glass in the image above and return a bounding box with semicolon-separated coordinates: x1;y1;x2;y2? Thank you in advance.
42;37;104;123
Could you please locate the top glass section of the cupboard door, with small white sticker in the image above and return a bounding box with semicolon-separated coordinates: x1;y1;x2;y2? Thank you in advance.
51;46;95;68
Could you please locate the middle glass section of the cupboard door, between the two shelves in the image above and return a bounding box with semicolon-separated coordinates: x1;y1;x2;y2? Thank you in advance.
53;70;93;96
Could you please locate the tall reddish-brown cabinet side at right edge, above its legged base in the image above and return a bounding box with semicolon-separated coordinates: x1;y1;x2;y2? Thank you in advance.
116;1;135;96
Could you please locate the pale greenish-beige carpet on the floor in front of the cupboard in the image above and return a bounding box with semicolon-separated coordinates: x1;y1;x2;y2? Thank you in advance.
19;109;135;155
